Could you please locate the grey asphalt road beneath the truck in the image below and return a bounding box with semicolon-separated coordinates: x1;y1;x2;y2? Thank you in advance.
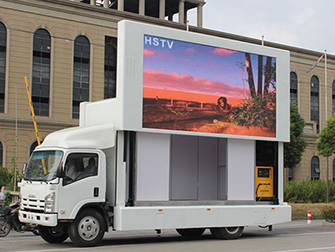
0;220;335;252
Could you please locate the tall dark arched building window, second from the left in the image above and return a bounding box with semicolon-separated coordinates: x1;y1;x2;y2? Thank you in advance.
31;29;51;116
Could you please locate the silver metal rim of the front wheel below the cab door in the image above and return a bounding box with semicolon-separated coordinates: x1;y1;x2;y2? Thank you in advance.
78;216;100;241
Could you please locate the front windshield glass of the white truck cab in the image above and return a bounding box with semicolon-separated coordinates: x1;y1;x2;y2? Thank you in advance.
24;151;63;181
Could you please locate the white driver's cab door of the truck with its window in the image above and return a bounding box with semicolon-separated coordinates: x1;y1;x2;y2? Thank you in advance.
58;152;106;219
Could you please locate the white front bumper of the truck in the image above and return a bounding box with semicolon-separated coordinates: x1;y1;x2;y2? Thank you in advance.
19;210;58;227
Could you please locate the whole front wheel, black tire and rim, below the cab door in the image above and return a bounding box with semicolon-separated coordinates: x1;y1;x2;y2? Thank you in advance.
69;209;106;247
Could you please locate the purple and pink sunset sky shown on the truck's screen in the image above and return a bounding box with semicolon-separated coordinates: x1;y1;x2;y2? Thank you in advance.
143;35;276;98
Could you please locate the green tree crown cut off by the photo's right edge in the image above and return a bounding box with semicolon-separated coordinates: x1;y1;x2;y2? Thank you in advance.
316;115;335;157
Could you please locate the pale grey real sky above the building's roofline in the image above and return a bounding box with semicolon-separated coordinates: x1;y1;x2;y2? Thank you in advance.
189;0;335;55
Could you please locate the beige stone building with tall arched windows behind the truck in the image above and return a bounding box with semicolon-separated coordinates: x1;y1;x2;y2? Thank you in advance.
0;0;335;181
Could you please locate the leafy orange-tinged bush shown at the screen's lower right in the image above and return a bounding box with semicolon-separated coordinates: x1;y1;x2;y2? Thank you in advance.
230;92;276;129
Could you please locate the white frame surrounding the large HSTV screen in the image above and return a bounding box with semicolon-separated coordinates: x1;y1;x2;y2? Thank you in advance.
117;20;290;142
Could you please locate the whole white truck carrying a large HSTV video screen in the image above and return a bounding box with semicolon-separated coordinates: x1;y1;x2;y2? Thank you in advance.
19;21;291;246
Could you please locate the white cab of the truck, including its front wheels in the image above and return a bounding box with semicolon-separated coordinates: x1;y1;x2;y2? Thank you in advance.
20;125;115;246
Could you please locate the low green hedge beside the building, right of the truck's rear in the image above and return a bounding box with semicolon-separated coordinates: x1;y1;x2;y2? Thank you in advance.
284;178;335;203
